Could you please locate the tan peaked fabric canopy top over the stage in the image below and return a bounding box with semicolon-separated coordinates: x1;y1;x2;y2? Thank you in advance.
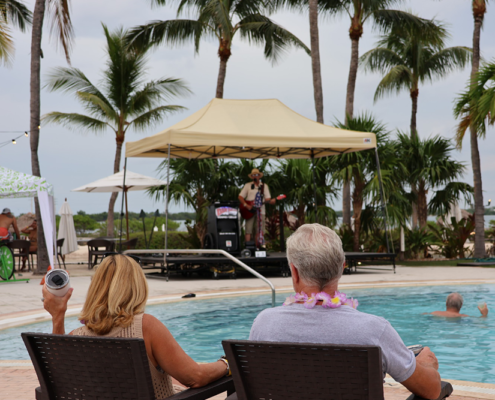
126;99;376;159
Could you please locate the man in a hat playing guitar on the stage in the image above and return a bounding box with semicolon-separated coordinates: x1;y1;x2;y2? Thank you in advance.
239;168;275;246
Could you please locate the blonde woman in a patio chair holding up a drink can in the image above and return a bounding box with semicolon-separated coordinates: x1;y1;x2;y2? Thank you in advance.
43;254;229;398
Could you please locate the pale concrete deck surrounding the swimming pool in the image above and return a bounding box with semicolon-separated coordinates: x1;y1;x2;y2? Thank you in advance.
0;264;495;400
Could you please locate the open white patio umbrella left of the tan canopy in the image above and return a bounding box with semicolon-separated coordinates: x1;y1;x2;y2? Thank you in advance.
72;170;167;240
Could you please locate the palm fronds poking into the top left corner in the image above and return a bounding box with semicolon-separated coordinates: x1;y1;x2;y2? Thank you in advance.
0;0;33;65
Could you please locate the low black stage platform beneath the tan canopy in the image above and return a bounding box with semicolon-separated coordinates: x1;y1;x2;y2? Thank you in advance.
139;252;396;281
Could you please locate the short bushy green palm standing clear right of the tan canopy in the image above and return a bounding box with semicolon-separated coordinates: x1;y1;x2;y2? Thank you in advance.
396;132;472;228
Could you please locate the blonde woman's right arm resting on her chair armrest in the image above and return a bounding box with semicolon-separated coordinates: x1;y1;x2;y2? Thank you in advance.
143;314;228;388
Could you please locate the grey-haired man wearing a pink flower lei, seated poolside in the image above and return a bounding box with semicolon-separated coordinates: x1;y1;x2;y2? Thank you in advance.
249;224;441;399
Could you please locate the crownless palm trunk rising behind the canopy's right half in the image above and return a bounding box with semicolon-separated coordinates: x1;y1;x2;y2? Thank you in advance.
309;0;323;123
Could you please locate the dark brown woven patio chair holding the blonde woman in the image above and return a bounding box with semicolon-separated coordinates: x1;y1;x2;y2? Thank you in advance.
21;333;234;400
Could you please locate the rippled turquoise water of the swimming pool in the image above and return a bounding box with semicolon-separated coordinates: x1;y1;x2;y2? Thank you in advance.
0;285;495;383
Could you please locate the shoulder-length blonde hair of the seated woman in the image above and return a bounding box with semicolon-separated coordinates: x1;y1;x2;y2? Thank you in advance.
79;254;148;335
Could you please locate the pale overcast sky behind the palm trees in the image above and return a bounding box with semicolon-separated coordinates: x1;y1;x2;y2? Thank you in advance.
0;0;495;215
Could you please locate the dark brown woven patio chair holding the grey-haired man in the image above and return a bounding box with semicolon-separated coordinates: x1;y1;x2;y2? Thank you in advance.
222;340;453;400
